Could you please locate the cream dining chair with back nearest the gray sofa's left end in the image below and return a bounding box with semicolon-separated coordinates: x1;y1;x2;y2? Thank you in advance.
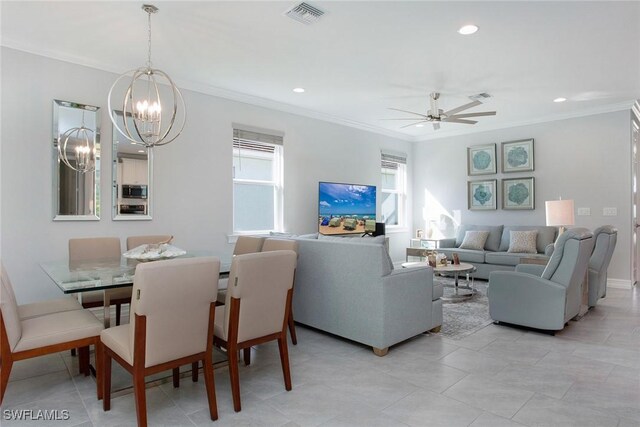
214;250;297;412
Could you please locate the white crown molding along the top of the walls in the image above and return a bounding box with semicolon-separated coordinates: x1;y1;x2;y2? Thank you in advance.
0;42;640;143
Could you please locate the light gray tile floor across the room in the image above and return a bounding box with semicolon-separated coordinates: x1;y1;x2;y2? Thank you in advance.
0;289;640;427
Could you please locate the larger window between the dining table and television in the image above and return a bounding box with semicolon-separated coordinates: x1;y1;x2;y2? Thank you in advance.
233;129;282;234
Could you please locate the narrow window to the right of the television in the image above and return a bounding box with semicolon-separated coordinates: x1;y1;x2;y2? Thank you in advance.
380;153;407;227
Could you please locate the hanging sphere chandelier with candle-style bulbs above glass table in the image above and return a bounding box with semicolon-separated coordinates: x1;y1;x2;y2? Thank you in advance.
108;4;186;148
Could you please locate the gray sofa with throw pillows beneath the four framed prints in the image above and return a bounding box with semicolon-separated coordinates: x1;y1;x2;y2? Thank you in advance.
437;225;558;280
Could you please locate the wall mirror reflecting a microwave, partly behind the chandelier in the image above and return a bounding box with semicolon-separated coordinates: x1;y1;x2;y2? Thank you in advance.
111;111;153;221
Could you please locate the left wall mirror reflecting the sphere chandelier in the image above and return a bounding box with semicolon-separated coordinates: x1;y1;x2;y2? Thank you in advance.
51;99;101;221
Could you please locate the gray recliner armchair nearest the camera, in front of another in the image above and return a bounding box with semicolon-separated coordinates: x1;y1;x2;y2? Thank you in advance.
488;228;593;331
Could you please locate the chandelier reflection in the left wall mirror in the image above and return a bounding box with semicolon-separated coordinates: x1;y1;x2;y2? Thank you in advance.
58;111;96;173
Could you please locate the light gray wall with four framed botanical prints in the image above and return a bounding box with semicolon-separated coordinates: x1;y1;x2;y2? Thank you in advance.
413;111;631;282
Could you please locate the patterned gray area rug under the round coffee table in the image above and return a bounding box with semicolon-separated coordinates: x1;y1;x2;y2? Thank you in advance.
433;275;492;340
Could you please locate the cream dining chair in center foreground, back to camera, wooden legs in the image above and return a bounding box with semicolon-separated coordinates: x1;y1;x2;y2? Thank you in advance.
100;257;220;426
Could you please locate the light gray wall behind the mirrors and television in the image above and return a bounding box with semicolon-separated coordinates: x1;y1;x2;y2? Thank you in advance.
0;48;412;303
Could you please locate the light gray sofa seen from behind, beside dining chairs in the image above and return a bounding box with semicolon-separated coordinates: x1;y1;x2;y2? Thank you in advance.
293;236;442;356
